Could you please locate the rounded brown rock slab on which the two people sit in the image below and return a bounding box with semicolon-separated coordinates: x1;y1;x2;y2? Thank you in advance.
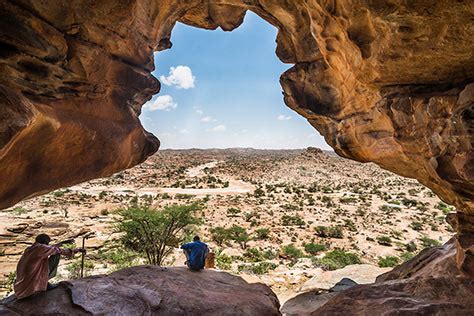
0;266;280;315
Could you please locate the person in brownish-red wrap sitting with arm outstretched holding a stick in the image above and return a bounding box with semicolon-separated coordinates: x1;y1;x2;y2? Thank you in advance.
13;234;85;298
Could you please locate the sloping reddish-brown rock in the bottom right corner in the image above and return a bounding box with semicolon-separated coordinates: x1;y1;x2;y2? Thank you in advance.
298;239;474;315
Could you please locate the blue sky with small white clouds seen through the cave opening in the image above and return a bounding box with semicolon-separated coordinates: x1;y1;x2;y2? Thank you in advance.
140;12;330;149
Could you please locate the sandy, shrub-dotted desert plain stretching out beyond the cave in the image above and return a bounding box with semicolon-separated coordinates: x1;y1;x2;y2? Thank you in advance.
0;148;452;301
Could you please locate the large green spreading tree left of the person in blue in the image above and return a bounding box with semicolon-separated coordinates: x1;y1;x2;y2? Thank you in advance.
117;203;200;265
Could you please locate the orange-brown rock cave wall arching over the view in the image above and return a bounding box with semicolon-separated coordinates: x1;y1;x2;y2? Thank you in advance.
0;0;474;269
